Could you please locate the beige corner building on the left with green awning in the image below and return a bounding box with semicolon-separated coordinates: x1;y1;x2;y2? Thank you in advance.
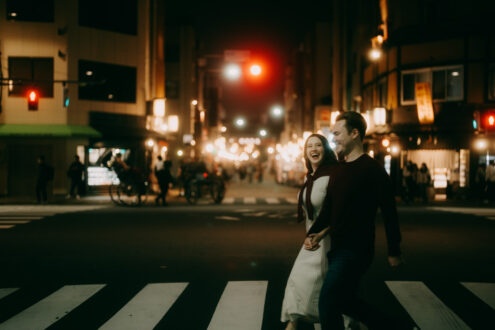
0;0;167;196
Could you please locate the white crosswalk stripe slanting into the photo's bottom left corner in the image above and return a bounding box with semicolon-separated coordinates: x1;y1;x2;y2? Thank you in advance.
0;284;105;330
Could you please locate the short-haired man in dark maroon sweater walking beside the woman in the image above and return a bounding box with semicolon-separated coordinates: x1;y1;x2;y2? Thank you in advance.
306;111;406;330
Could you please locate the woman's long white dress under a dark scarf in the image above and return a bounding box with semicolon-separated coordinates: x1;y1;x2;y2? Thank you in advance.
281;176;330;323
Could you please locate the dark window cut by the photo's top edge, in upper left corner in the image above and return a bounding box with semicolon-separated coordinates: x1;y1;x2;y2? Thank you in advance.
7;0;54;22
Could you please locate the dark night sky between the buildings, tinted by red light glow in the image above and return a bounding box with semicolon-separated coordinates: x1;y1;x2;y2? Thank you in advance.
166;0;331;135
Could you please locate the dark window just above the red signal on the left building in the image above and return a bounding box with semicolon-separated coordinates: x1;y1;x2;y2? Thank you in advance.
9;57;53;97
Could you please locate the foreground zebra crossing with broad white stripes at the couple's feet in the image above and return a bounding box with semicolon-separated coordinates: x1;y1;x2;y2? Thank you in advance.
0;281;495;330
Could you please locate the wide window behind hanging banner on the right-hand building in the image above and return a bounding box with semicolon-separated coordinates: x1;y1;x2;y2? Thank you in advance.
401;66;464;105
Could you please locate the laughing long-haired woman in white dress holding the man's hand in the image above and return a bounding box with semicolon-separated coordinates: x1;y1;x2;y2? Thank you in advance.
281;134;356;330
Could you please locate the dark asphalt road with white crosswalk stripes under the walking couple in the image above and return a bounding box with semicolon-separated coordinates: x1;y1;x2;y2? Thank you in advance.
0;202;495;330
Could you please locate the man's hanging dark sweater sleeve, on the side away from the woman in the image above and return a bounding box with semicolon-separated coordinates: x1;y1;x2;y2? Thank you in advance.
377;169;401;256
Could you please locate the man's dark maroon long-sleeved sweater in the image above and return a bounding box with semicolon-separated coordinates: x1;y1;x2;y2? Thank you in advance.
308;154;401;256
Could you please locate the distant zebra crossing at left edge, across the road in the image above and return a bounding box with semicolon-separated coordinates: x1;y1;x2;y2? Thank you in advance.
0;205;106;230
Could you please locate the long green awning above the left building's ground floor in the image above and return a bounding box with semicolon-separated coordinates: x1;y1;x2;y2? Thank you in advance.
0;124;102;138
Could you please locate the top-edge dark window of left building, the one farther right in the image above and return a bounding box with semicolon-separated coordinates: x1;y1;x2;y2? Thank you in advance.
79;0;138;35
